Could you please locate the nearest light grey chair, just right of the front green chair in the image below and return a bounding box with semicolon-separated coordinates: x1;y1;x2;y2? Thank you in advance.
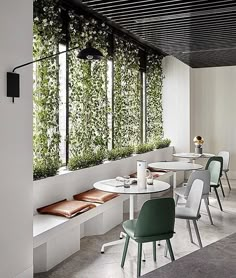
175;179;204;248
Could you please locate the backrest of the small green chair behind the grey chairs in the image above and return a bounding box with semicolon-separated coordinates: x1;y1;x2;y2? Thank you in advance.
205;156;223;184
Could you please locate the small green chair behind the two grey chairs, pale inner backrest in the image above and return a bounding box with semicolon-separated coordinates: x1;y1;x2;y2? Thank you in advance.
205;156;224;211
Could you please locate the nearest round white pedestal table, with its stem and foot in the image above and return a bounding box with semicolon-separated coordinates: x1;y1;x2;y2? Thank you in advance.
93;179;170;254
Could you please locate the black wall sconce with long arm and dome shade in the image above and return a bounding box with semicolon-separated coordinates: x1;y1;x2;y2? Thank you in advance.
7;43;103;103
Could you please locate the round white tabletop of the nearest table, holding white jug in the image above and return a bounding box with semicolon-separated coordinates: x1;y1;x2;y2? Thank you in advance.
93;179;170;195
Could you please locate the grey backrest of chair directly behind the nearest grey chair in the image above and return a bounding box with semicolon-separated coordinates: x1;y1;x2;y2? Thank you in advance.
185;170;210;197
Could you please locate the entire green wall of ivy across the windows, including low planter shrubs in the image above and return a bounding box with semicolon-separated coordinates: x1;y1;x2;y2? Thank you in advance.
33;3;166;179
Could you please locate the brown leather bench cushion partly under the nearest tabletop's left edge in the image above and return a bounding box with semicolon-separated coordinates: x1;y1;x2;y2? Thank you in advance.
73;188;118;204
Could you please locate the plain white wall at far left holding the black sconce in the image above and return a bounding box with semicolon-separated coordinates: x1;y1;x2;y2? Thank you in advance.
0;0;33;278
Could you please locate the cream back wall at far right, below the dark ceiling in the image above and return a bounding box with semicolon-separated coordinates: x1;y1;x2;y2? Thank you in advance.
191;66;236;178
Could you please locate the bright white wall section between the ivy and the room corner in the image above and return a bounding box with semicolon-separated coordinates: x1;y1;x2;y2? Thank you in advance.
163;56;190;152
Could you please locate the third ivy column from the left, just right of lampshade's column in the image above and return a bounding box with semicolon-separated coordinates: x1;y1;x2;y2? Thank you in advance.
113;37;141;148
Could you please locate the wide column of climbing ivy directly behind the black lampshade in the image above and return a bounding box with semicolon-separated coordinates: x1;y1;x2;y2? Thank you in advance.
69;13;110;159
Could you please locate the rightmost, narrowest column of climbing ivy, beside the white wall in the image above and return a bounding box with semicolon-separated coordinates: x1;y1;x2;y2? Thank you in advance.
146;54;164;142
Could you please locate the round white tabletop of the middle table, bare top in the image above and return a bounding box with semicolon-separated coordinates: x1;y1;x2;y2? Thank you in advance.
148;161;203;171
